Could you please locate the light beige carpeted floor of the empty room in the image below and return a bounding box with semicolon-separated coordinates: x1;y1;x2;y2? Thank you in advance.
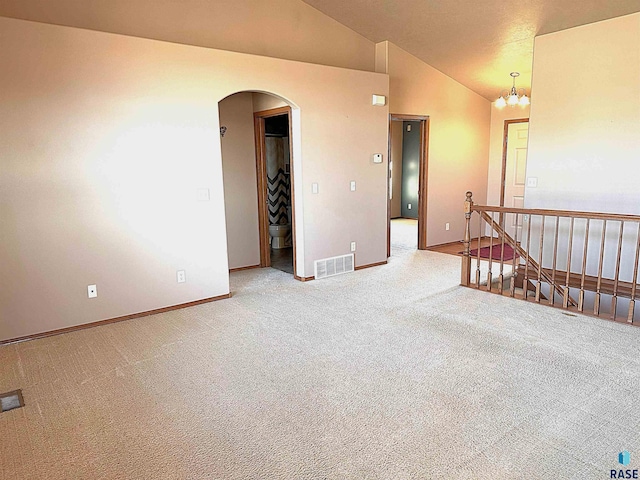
0;225;640;480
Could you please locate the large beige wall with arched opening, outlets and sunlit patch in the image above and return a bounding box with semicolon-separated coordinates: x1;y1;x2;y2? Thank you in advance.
0;18;388;339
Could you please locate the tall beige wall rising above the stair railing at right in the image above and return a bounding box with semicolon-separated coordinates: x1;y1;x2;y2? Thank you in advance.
525;14;640;214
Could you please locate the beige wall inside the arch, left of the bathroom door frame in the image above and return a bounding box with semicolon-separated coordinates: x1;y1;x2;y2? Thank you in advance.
219;92;260;269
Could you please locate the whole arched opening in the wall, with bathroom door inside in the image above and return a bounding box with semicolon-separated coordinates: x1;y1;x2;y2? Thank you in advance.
218;92;296;277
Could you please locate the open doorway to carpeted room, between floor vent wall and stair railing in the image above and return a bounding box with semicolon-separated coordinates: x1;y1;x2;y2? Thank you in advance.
387;114;429;257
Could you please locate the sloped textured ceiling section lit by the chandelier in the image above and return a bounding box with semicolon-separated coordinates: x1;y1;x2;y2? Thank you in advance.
303;0;640;100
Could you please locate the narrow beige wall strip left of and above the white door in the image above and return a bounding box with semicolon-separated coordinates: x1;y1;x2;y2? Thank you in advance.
490;105;529;205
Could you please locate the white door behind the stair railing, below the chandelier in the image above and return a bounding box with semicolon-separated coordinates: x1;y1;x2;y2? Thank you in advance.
504;121;529;240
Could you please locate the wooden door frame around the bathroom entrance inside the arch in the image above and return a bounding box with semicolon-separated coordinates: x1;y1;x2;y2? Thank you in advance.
253;106;297;277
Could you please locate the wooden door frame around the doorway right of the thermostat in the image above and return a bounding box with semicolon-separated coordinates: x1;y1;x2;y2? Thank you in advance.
387;113;430;258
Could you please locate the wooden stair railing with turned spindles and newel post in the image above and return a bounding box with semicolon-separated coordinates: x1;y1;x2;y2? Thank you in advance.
461;192;640;325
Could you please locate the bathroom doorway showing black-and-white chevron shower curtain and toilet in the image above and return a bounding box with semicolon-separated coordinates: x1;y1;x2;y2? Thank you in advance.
254;107;295;275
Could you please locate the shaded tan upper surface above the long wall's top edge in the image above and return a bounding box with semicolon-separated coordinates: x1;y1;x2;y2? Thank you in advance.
0;0;375;71
